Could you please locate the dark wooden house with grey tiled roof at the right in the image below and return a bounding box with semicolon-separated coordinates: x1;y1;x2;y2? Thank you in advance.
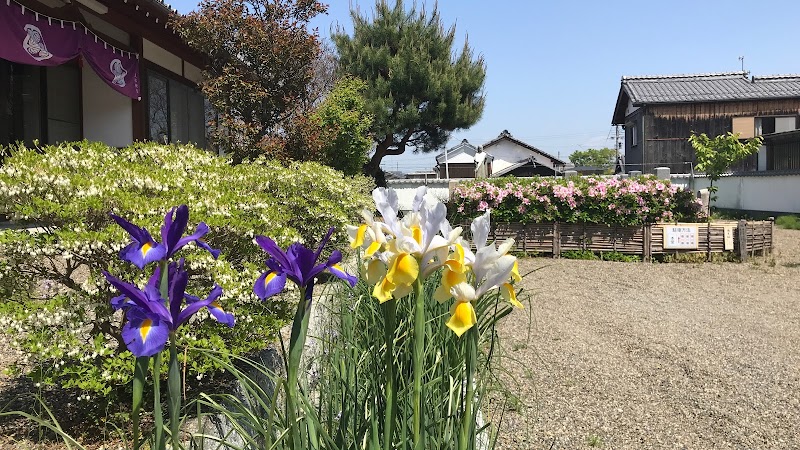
611;72;800;173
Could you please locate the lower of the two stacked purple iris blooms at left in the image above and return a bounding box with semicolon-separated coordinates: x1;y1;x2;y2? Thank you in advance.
103;261;234;357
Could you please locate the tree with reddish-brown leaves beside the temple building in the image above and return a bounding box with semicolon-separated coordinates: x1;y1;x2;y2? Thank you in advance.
175;0;326;162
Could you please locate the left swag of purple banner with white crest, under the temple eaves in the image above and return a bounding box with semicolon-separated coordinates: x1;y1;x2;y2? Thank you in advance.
0;2;83;66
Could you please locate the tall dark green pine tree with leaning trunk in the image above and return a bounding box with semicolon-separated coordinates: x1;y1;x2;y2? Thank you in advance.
332;0;486;176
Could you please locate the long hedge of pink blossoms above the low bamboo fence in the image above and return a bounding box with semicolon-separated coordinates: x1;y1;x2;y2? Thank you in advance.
449;176;704;226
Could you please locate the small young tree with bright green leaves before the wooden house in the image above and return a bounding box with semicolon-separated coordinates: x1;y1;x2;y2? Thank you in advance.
689;132;763;216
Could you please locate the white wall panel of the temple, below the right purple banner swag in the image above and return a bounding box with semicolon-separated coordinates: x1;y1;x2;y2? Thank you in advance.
81;64;133;147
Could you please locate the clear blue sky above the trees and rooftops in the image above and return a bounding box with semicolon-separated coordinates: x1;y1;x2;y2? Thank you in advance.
172;0;800;172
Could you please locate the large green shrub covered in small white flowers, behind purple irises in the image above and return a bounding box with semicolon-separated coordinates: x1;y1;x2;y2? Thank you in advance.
0;142;372;399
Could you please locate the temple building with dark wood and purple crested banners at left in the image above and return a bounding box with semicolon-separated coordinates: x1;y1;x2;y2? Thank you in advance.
0;0;206;147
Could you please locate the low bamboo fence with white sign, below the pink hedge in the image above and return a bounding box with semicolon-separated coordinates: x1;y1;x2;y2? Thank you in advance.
472;220;774;260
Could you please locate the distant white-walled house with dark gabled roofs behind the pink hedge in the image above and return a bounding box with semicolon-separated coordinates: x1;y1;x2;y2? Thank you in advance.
434;130;566;178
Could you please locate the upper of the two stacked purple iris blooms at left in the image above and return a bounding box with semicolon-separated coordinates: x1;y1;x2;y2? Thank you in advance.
111;205;219;269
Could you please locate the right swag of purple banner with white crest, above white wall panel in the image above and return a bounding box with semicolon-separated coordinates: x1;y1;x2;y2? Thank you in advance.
81;33;141;99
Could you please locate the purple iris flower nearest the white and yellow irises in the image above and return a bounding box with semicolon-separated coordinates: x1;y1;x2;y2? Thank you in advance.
253;227;356;300
